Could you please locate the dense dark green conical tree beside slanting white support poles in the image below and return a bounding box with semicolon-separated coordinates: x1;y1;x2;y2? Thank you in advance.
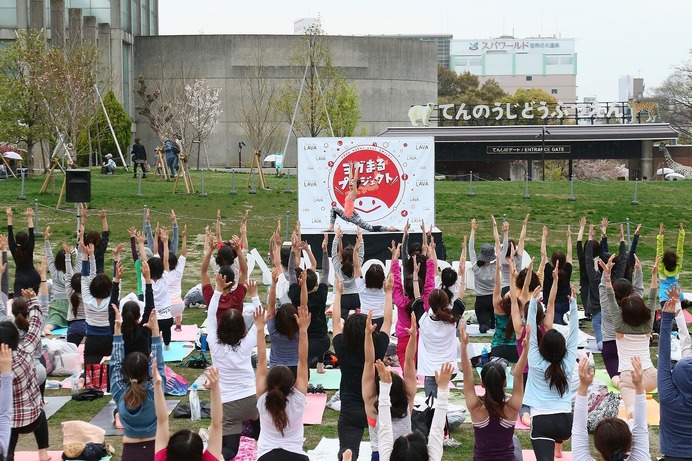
77;90;132;165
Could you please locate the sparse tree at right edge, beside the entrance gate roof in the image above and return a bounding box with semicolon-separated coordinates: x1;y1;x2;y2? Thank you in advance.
653;60;692;144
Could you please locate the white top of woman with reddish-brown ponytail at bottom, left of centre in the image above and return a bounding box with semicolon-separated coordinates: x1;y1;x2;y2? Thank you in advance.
257;388;307;458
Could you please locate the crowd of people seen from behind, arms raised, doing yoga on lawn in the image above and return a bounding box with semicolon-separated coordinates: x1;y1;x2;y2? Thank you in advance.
0;205;692;461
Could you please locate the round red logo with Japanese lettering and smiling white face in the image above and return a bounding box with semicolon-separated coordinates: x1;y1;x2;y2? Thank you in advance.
328;145;406;222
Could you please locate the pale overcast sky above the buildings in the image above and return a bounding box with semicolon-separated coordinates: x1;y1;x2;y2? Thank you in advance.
159;0;692;101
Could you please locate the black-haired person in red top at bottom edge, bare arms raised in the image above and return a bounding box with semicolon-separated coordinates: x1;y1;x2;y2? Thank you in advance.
151;360;224;461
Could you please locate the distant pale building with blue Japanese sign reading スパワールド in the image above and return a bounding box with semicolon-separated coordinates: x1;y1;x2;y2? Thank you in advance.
450;36;577;102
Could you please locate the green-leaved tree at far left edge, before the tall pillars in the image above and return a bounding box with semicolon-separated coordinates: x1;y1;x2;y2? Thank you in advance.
0;30;52;169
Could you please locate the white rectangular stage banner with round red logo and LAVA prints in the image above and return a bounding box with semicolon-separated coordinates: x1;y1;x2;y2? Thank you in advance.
298;137;435;230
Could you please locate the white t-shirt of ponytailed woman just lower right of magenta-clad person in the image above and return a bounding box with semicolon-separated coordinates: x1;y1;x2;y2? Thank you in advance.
418;311;460;376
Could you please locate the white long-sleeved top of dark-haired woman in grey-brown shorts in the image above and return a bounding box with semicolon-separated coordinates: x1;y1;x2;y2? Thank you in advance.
207;291;260;402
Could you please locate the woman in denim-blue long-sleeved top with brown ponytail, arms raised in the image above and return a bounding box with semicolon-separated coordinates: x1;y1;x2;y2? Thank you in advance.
110;304;166;461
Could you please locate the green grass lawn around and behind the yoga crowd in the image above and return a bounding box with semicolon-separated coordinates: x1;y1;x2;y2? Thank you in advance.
0;171;692;460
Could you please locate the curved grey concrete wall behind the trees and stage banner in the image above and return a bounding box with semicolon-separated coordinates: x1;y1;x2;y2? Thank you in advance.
133;35;437;167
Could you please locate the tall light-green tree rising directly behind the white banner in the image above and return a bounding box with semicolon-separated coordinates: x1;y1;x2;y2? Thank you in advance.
277;24;360;138
